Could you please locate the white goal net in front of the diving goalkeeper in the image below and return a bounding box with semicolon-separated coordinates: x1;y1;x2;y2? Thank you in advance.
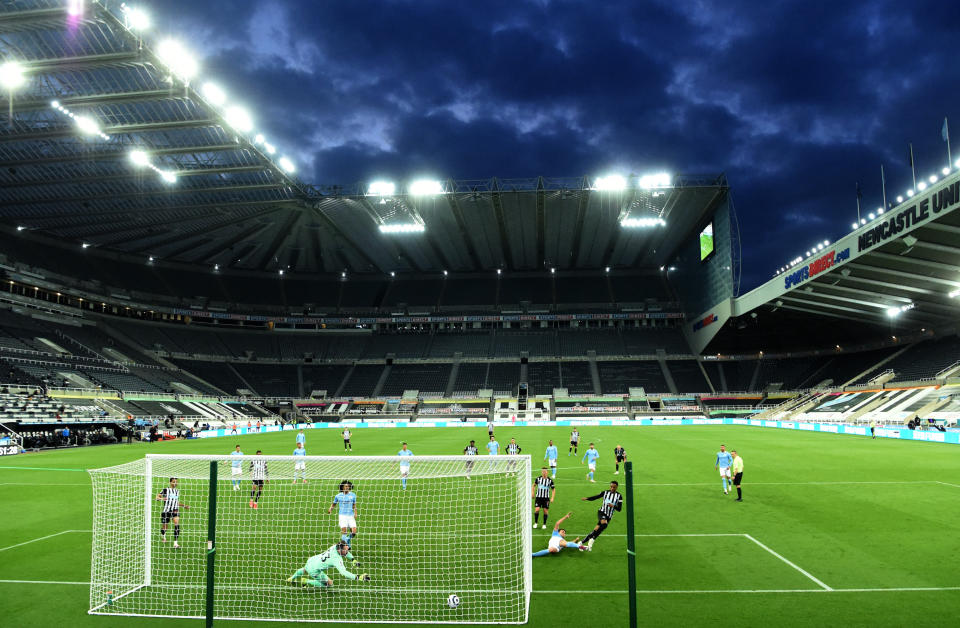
89;454;532;624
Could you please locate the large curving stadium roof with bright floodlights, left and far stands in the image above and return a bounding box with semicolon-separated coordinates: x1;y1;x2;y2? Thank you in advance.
0;0;727;273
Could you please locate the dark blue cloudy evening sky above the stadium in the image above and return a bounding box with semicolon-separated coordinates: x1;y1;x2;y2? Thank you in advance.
151;0;960;291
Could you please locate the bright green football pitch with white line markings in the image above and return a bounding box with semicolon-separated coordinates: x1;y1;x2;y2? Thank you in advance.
0;426;960;628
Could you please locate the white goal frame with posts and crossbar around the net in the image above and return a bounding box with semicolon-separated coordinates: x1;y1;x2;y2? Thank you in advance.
87;453;533;625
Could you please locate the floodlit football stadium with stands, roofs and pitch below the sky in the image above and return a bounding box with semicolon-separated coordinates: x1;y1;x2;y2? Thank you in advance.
0;0;960;628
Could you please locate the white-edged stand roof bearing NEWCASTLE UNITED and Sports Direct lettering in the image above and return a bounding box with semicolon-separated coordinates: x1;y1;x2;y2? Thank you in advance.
692;171;960;349
